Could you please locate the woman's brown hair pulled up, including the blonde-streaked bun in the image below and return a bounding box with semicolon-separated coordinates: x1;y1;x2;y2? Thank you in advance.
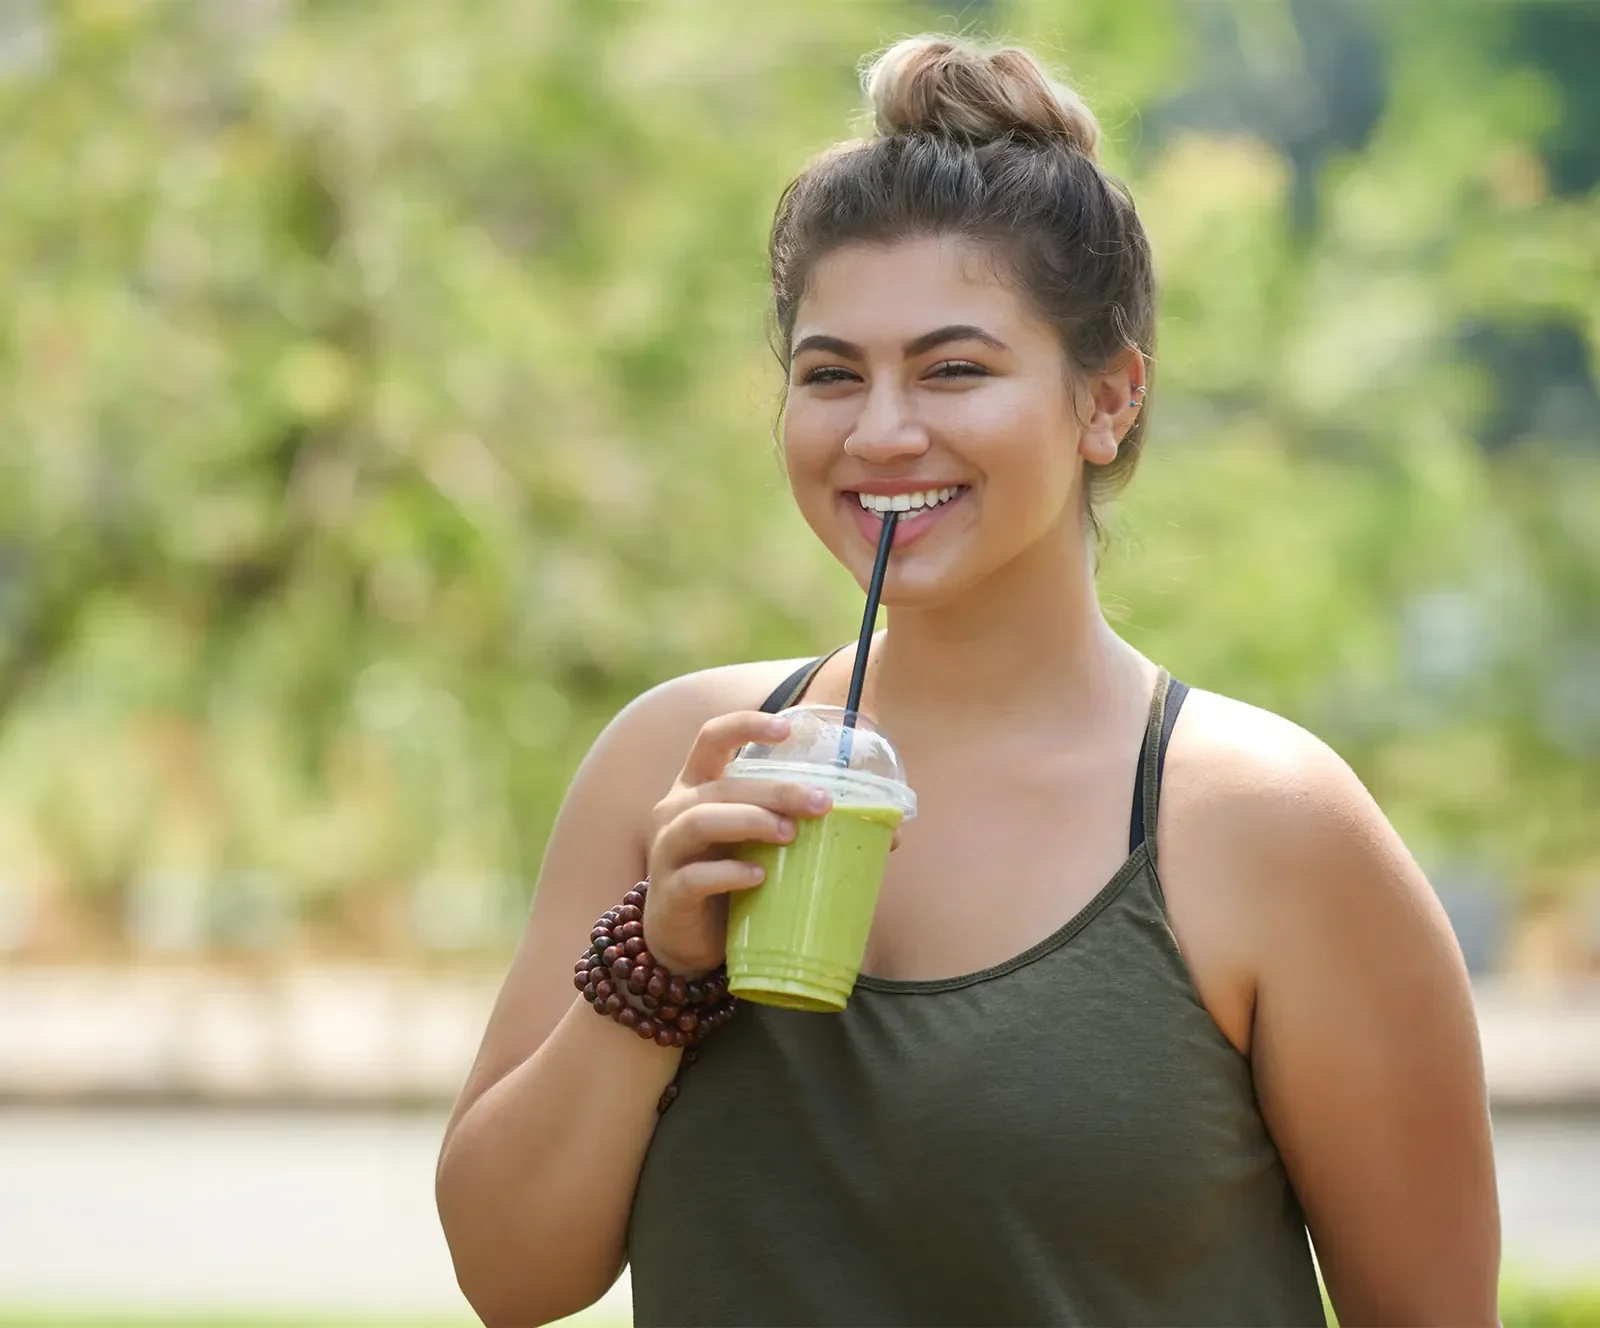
768;37;1155;528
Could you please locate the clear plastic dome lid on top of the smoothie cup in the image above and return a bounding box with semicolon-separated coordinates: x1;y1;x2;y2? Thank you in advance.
728;706;917;821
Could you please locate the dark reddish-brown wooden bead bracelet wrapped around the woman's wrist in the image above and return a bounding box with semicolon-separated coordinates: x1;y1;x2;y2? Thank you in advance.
573;880;739;1112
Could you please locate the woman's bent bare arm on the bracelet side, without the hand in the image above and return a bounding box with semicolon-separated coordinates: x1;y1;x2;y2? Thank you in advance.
435;666;800;1328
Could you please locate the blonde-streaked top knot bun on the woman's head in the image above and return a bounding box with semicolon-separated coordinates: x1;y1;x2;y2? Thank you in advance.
862;37;1101;160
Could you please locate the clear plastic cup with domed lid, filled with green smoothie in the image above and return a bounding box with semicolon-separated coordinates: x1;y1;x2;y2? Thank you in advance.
728;706;917;1013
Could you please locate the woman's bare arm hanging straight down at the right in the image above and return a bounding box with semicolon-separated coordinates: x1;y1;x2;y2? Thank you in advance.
1230;725;1501;1328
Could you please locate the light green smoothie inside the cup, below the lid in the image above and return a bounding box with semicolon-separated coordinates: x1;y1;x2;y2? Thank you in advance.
728;805;904;1011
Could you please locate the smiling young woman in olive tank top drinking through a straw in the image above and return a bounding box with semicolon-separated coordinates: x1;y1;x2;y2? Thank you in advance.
438;38;1499;1325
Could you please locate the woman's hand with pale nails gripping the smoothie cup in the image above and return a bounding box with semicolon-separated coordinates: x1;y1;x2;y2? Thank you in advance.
645;710;832;978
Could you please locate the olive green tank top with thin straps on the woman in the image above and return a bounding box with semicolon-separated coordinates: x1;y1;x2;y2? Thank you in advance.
629;666;1325;1328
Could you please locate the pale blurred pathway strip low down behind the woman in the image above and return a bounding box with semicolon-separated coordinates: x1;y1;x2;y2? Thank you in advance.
0;1107;1600;1323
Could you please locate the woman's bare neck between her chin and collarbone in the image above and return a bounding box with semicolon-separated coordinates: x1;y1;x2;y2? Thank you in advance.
872;515;1154;733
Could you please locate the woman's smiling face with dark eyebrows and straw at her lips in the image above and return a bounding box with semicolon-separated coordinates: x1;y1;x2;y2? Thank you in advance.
782;237;1109;605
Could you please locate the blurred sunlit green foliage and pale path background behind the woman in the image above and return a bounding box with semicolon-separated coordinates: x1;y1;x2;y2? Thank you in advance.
0;0;1600;1325
